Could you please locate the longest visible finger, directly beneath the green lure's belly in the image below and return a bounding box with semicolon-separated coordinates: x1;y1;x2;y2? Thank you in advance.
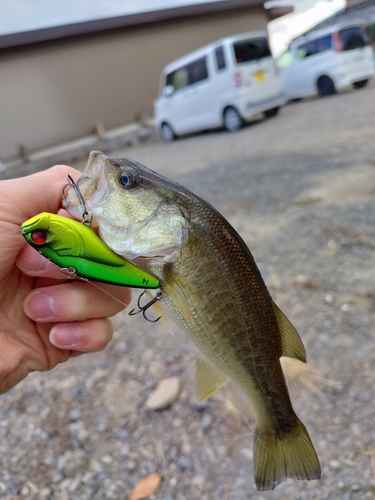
23;281;131;323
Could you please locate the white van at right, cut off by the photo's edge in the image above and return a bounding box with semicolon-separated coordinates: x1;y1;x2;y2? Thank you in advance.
277;22;375;99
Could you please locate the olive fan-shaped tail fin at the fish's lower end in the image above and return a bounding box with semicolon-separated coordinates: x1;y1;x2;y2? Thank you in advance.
254;419;320;491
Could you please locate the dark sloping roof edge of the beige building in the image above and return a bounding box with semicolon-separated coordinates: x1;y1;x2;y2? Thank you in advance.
0;0;264;49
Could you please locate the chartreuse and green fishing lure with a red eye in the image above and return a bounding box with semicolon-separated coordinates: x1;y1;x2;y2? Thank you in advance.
21;212;159;289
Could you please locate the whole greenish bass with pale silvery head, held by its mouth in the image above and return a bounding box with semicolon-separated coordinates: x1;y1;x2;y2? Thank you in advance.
65;151;321;491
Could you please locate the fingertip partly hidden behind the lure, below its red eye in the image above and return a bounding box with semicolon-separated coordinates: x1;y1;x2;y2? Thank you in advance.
16;245;64;279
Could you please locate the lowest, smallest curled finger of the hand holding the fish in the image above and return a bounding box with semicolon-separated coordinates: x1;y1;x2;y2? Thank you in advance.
49;318;113;355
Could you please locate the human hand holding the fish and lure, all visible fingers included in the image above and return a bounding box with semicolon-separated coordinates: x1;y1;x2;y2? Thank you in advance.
0;165;131;393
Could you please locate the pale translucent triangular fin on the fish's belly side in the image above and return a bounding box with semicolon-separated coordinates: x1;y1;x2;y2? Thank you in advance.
195;354;229;403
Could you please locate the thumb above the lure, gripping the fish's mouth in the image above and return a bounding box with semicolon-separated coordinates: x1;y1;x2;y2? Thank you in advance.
0;165;81;226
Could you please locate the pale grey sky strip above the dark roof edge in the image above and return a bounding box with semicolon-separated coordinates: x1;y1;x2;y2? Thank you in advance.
0;0;217;35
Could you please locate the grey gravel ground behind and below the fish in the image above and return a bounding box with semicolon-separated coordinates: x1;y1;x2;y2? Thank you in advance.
0;83;375;500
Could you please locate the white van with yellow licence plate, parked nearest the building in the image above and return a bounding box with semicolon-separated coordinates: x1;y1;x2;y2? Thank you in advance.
154;31;285;142
